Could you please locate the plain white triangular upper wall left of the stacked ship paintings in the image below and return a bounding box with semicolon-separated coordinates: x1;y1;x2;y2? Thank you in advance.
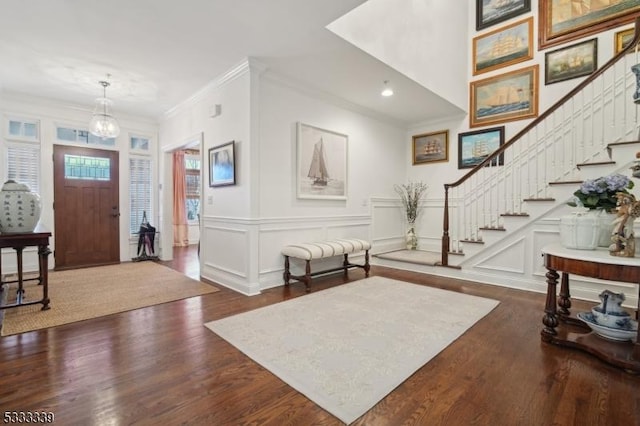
327;0;468;110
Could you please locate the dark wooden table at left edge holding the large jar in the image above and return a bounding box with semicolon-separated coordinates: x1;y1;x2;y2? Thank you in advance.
0;228;51;311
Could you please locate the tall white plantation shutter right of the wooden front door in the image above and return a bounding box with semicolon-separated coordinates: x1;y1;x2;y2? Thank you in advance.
129;157;151;234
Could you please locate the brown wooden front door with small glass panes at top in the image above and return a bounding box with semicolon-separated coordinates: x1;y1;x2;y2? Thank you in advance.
53;145;120;269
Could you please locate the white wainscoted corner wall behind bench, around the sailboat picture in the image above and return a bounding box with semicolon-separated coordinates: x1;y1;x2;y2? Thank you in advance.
160;61;405;294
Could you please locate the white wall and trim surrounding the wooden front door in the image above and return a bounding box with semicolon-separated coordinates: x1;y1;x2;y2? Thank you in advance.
0;93;162;273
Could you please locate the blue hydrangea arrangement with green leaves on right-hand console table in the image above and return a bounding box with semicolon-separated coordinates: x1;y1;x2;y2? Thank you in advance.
567;173;633;212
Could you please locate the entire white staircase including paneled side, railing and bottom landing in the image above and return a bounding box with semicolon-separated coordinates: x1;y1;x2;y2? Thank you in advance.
376;18;640;309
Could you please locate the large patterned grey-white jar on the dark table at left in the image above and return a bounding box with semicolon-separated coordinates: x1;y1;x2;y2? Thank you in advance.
0;180;42;234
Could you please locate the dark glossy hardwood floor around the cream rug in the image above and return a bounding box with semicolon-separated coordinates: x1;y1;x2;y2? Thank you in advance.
0;246;640;426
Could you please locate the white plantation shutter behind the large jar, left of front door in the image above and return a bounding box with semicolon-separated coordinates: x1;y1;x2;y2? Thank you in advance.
7;142;40;194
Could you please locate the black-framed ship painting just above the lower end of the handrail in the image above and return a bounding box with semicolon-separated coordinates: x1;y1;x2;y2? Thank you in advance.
458;126;504;169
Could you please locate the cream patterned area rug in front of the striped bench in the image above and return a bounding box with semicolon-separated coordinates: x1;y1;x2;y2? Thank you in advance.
205;277;499;424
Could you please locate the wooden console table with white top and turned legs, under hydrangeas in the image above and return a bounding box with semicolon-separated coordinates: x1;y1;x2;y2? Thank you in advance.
541;244;640;373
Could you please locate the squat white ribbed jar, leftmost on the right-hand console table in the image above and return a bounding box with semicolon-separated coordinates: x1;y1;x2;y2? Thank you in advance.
560;210;600;250
